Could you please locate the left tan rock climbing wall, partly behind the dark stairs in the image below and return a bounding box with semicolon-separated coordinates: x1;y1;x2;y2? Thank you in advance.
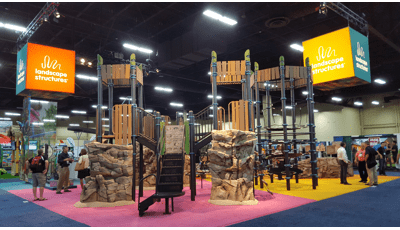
81;142;190;202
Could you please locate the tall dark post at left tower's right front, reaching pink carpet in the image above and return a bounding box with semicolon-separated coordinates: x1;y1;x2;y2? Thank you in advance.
130;54;137;201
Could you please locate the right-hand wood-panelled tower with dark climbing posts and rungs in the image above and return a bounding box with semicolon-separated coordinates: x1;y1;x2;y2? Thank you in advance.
211;50;318;190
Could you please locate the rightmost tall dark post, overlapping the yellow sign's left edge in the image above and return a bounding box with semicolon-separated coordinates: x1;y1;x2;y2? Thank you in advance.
306;58;318;189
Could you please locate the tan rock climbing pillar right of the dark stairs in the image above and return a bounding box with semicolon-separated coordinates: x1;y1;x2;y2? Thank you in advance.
208;130;256;202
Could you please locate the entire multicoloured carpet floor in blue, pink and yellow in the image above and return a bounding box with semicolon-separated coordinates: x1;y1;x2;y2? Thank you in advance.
0;172;400;227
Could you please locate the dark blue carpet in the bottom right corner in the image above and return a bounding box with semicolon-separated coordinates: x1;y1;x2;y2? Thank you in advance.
231;180;400;227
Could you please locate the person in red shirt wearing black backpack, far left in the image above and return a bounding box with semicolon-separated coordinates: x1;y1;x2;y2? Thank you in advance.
26;149;49;201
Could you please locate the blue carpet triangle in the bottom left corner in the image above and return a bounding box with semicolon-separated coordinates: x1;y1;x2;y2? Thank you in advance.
0;189;89;227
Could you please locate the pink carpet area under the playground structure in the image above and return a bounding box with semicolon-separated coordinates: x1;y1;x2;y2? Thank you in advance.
9;181;315;227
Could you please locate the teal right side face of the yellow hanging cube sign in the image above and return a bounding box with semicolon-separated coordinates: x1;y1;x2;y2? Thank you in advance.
350;28;371;83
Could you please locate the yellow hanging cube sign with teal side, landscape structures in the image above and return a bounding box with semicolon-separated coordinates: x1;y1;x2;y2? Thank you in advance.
303;27;371;90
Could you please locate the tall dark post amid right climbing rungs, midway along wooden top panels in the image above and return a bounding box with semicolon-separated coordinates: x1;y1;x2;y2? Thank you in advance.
279;56;290;190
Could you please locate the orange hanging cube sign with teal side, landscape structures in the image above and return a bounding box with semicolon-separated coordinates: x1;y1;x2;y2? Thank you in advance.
16;43;75;99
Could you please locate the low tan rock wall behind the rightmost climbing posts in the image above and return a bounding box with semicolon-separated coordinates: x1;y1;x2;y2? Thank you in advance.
298;157;354;178
